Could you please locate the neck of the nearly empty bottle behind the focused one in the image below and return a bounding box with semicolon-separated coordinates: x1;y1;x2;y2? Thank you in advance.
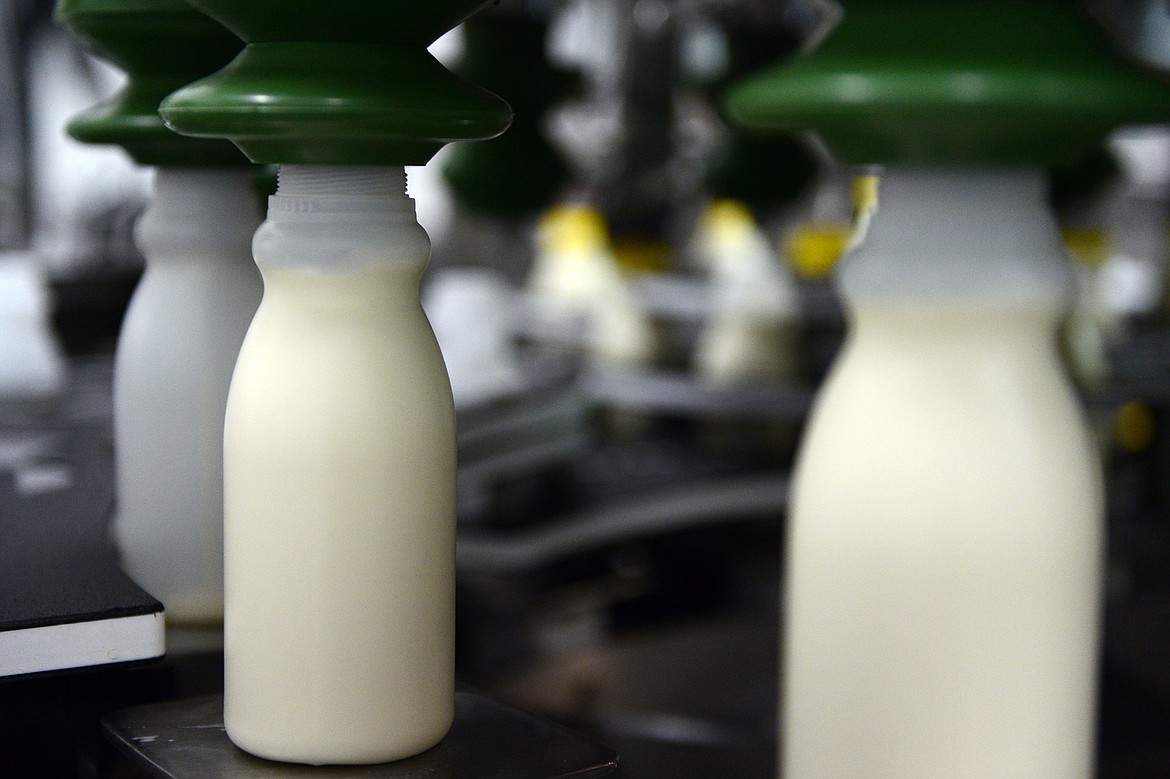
135;167;261;264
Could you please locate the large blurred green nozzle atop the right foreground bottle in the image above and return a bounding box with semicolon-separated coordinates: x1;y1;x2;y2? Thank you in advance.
727;0;1170;165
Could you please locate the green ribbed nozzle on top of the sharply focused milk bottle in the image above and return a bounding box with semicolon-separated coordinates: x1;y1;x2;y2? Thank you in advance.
161;0;511;165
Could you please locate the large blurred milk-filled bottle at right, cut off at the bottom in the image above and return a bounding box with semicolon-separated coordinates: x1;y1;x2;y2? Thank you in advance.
780;171;1102;779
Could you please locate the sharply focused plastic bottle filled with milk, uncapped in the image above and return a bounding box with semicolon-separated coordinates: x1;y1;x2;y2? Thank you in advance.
223;160;455;764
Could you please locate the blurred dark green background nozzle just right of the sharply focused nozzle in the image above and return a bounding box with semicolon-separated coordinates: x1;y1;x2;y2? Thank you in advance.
443;11;579;220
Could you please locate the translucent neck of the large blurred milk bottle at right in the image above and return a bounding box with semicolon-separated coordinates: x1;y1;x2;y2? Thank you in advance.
839;168;1072;311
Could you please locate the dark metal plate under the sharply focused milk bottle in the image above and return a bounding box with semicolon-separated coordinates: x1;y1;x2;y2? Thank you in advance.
104;688;618;779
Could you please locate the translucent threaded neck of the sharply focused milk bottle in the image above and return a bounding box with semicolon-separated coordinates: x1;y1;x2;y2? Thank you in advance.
253;165;431;275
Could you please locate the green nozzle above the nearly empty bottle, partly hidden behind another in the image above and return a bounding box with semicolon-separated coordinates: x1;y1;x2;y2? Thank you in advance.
55;0;248;166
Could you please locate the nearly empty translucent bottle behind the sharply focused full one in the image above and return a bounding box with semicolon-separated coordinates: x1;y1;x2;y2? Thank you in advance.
112;168;261;625
